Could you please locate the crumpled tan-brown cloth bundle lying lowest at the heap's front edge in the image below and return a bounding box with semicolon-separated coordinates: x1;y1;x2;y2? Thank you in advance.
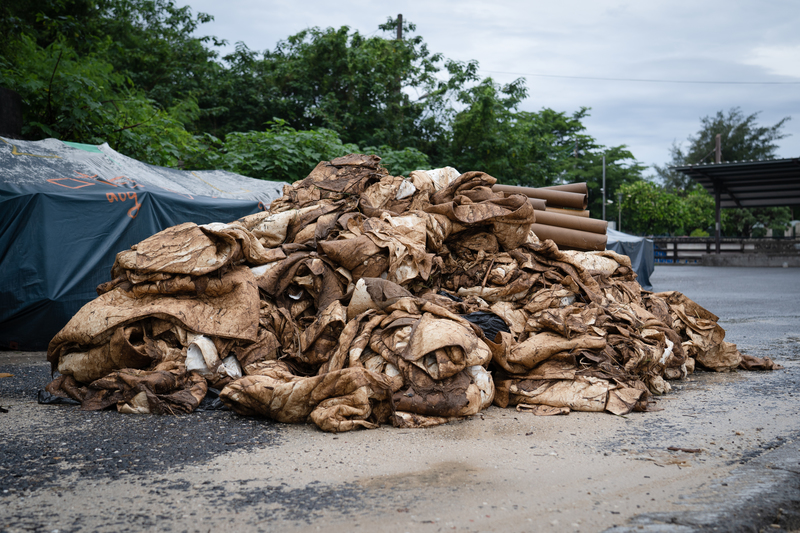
220;362;391;432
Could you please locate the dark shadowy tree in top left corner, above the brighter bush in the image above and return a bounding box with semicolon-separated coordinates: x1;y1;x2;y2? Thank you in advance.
0;0;223;109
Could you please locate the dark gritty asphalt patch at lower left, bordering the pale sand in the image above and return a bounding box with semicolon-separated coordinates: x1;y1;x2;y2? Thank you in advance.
0;362;280;498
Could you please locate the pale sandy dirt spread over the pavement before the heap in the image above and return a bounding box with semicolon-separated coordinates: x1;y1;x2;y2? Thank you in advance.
0;348;800;531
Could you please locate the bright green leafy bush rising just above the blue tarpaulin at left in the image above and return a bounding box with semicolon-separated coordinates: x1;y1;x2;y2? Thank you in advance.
0;35;198;166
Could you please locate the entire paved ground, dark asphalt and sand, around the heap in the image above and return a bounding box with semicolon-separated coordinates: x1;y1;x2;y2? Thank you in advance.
0;266;800;533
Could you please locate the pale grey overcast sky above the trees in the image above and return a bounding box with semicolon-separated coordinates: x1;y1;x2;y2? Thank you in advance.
178;0;800;172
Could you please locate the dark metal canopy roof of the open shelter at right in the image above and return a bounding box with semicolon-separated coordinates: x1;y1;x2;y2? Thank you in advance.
672;157;800;207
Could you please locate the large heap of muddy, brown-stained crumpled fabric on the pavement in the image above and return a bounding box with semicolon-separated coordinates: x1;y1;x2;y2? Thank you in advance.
47;155;774;431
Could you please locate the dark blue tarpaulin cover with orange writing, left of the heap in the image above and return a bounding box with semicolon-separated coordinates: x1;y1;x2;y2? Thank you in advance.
0;138;283;350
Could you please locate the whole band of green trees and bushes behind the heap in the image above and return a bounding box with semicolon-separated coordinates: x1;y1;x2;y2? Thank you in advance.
0;0;791;236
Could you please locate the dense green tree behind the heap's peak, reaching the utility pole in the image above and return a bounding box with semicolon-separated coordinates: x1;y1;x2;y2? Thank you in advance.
203;19;447;148
